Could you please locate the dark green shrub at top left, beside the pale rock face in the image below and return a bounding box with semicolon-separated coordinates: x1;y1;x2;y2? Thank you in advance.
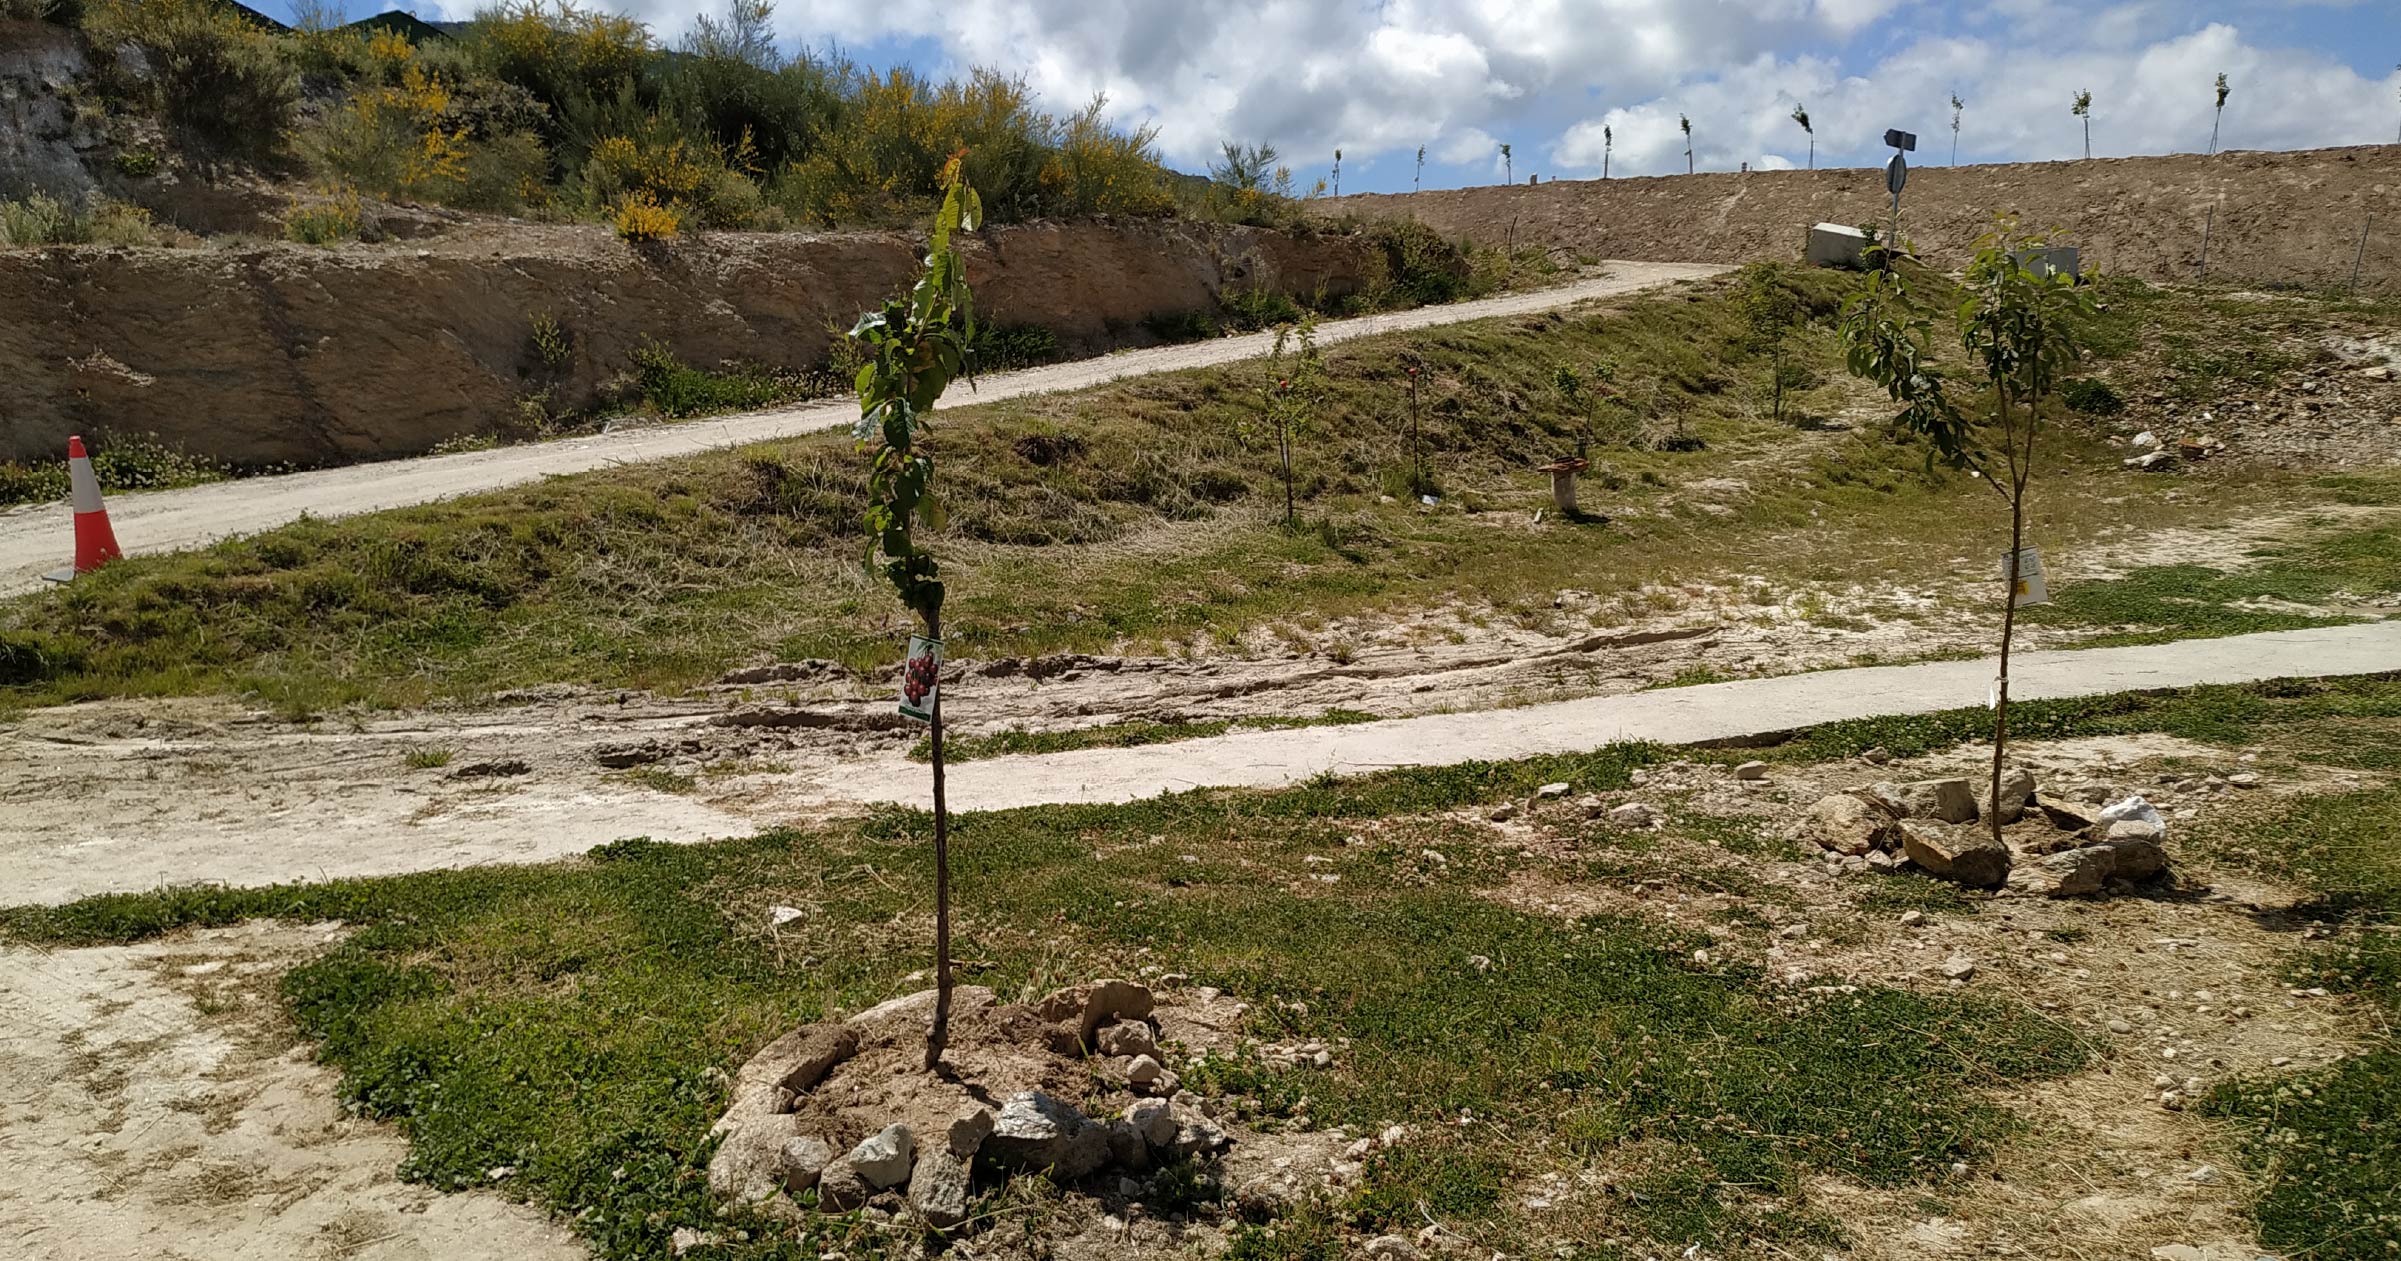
84;0;300;161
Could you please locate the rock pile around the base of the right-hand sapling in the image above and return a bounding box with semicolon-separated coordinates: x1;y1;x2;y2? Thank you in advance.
1801;769;2168;898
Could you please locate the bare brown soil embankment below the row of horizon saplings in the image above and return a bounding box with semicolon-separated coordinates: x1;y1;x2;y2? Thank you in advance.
1328;144;2401;293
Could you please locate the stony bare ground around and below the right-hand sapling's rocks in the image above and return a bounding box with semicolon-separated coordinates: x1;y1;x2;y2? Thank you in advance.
1465;735;2379;1261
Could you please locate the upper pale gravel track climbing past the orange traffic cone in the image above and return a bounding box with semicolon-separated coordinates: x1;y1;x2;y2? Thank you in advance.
0;262;1726;596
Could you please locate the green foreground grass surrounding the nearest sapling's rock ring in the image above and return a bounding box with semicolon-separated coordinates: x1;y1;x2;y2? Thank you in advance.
7;754;2082;1259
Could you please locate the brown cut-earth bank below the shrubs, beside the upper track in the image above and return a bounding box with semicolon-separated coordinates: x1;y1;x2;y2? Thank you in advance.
0;221;1381;464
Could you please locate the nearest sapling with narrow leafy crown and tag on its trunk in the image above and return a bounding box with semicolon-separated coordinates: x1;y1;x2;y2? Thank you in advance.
850;149;984;1071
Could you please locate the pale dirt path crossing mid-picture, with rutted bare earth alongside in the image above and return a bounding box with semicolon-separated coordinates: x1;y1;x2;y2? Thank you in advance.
0;620;2401;903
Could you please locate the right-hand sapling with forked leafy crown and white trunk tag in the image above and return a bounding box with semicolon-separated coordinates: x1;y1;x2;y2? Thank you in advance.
1842;219;2096;843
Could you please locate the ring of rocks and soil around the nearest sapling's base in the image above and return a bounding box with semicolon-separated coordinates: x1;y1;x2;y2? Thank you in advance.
708;980;1234;1230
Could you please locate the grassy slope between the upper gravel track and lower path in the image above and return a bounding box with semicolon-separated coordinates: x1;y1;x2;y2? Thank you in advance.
0;270;1966;711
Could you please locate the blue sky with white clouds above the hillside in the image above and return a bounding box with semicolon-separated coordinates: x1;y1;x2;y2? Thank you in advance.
262;0;2401;192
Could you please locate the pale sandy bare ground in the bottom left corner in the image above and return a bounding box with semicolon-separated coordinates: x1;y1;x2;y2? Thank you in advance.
0;925;583;1261
